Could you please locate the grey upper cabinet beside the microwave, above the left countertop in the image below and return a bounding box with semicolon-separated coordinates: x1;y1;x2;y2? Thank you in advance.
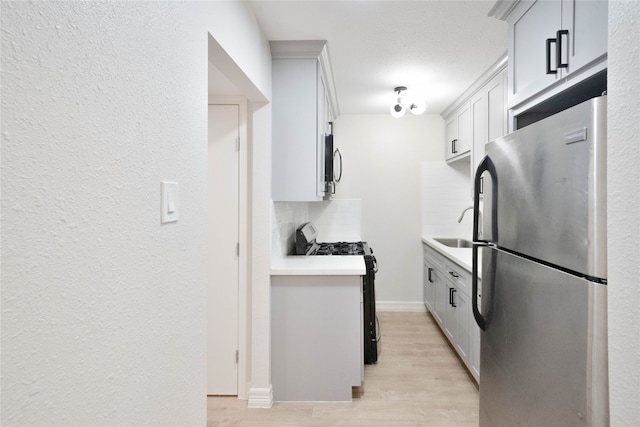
271;41;337;202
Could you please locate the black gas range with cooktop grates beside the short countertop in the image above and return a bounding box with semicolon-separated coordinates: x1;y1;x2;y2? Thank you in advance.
296;222;379;364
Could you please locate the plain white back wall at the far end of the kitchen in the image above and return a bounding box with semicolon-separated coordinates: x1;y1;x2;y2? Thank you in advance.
335;114;444;302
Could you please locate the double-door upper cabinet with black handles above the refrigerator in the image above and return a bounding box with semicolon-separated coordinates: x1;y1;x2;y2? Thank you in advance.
490;0;608;112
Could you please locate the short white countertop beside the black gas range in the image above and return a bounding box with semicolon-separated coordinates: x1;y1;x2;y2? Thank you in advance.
271;255;366;276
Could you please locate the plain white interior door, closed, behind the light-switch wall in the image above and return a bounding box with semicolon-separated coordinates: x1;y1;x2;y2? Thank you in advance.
207;105;239;395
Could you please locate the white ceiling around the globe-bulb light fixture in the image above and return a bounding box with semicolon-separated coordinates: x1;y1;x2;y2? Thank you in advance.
211;0;507;114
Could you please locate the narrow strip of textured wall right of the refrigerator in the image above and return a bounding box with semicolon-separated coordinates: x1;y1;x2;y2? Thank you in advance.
607;1;640;426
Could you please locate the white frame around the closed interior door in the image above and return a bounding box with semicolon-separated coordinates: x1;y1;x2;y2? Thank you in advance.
208;96;250;400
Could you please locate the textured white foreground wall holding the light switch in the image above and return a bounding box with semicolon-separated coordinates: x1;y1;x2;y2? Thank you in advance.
0;1;270;425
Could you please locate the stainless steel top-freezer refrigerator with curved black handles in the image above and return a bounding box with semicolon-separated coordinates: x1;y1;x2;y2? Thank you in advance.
473;96;609;427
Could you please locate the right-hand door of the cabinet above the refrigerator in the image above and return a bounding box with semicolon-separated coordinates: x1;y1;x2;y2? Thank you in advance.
562;0;608;73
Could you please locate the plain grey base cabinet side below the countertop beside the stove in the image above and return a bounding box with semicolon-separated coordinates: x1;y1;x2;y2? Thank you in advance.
271;275;364;401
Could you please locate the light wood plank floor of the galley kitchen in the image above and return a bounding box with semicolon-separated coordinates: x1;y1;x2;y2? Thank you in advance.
207;312;478;427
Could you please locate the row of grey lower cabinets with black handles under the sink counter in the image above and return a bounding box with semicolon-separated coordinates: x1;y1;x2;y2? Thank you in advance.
423;244;480;381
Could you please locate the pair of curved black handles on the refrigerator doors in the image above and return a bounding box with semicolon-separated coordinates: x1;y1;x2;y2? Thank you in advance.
471;156;498;331
